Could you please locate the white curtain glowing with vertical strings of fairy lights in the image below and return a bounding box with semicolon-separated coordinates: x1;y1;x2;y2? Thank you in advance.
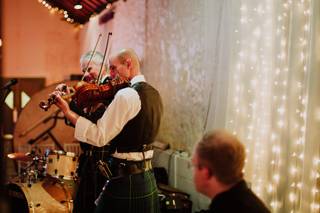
227;0;320;213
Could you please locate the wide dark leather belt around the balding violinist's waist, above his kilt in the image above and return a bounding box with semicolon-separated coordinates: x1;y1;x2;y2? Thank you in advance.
112;158;152;177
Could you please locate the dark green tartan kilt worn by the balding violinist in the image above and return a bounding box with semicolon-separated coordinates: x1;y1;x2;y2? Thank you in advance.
95;170;160;213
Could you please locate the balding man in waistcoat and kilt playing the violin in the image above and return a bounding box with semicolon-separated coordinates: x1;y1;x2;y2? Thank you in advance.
56;49;163;213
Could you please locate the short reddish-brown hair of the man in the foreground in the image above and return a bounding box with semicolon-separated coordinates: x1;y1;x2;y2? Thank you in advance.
196;130;245;184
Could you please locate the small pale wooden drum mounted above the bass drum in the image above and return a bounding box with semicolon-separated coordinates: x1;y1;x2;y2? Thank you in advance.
47;152;78;180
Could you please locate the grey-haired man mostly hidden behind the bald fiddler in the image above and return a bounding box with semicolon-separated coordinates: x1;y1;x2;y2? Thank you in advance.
56;51;109;213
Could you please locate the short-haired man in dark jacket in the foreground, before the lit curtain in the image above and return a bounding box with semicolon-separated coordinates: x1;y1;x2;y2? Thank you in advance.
192;130;270;213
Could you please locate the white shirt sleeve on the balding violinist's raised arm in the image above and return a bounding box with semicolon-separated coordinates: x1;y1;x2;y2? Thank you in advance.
74;87;141;147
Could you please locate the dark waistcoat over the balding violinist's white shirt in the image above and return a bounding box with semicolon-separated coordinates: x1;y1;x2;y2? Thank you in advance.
110;82;163;153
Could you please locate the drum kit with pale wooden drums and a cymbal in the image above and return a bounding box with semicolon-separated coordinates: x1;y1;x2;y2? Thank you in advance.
7;151;78;212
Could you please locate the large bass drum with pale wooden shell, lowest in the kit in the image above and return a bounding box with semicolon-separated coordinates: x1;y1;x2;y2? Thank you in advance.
6;177;75;213
